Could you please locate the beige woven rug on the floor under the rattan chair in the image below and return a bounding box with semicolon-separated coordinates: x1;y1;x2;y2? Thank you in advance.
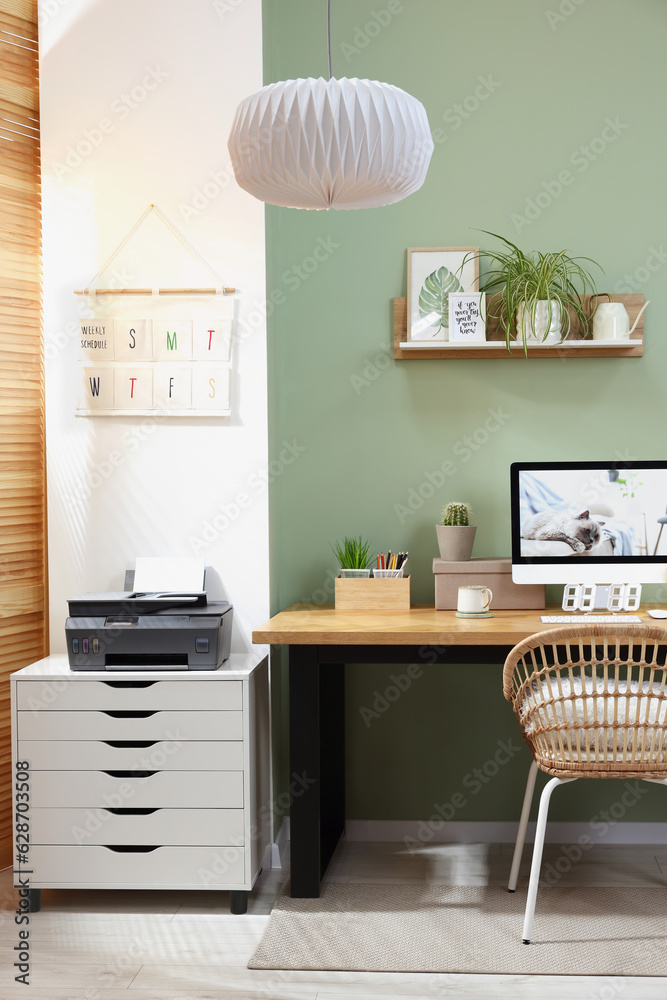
248;882;667;976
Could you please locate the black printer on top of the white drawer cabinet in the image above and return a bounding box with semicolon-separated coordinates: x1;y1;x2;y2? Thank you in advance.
65;591;233;670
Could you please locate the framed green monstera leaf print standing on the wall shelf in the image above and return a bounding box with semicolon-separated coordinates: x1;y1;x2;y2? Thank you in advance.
408;247;479;342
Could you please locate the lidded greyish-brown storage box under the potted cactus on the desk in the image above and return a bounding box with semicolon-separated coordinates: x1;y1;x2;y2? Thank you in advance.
433;559;545;611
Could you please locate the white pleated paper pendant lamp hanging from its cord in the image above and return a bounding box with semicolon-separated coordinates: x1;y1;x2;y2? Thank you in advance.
228;0;433;209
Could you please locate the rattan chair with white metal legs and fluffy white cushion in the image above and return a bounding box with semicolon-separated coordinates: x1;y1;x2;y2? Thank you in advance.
503;624;667;944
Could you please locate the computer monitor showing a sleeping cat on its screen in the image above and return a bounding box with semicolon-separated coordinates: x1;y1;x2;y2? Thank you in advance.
510;460;667;584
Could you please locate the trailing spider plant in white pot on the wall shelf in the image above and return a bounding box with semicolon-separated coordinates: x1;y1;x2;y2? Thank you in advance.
468;230;602;355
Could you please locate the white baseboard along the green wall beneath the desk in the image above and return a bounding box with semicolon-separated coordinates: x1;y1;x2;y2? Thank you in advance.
348;819;667;844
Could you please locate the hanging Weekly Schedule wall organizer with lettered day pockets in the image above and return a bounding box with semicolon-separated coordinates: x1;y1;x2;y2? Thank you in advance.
75;204;236;417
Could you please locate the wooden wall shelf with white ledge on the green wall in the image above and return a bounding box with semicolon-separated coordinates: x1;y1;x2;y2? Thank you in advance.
394;294;644;361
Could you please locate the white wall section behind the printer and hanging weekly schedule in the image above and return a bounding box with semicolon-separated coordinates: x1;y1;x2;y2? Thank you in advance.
40;0;269;651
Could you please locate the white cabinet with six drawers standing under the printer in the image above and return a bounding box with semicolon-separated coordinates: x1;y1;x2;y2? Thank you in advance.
11;654;271;912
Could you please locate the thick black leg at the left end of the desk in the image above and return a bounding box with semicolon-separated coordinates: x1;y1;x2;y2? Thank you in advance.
289;646;345;898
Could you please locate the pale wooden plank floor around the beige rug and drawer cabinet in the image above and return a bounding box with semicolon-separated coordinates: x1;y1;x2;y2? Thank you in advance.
0;843;667;1000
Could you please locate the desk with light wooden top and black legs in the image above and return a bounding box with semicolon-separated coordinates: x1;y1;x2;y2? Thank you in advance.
252;604;659;897
